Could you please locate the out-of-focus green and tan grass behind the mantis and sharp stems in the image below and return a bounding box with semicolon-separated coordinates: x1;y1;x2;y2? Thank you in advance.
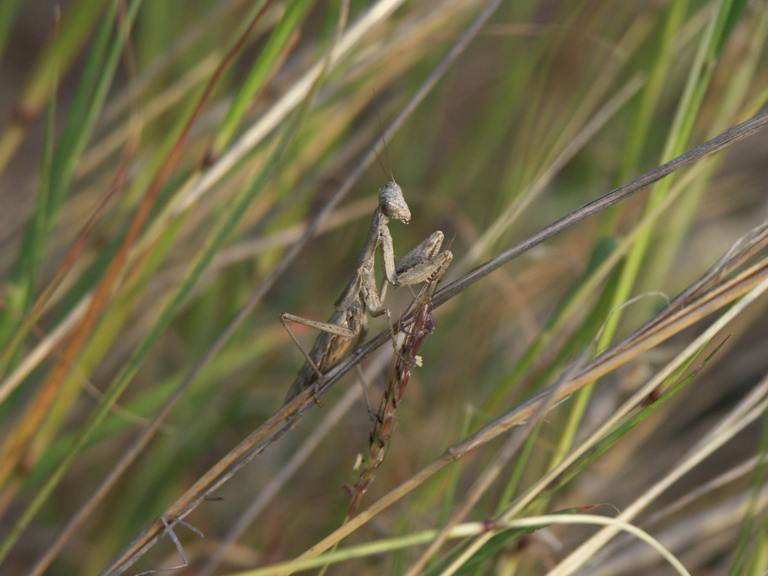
0;0;768;574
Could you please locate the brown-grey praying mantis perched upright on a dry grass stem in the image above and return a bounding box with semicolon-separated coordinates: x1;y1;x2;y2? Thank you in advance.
280;180;453;403
